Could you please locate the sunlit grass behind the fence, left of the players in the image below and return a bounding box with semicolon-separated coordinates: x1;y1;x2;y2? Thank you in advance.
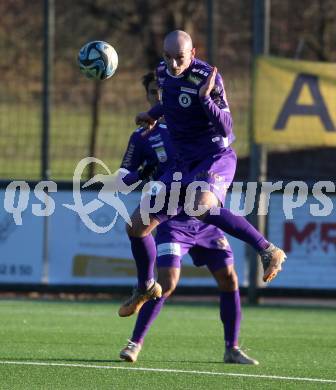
0;104;136;180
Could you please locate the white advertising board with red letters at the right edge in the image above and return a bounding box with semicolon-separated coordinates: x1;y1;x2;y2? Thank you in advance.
268;194;336;289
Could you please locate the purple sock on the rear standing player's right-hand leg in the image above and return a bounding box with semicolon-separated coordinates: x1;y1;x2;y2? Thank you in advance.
220;290;241;348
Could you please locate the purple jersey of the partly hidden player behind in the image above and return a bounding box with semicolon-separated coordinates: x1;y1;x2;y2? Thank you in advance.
121;123;174;185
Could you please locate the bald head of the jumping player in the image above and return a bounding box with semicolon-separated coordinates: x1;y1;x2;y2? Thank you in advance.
163;30;195;76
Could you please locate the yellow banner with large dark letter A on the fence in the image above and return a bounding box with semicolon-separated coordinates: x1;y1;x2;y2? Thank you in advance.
253;57;336;146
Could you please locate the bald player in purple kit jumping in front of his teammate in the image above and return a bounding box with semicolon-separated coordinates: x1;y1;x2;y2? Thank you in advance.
119;30;286;316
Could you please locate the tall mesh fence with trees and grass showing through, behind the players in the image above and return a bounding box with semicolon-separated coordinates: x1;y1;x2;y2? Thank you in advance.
0;0;336;179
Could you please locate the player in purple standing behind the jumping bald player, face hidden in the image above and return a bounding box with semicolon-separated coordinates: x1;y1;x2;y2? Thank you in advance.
120;73;258;364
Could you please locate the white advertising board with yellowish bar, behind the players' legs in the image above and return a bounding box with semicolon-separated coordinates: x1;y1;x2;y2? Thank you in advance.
48;191;246;286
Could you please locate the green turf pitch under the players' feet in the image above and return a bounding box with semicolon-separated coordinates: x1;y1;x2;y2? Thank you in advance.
0;300;336;389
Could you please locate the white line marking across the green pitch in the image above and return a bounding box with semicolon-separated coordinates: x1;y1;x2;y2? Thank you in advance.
0;360;336;383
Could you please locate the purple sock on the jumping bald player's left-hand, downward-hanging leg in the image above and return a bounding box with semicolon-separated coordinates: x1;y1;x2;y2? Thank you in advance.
130;234;156;289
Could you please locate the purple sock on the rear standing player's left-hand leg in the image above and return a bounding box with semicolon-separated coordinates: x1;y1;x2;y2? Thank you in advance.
131;297;166;344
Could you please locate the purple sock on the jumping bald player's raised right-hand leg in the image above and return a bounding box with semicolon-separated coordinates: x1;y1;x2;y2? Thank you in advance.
203;208;269;252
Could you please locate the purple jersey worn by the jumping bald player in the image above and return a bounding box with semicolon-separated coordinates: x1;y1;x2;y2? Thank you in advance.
148;59;234;163
